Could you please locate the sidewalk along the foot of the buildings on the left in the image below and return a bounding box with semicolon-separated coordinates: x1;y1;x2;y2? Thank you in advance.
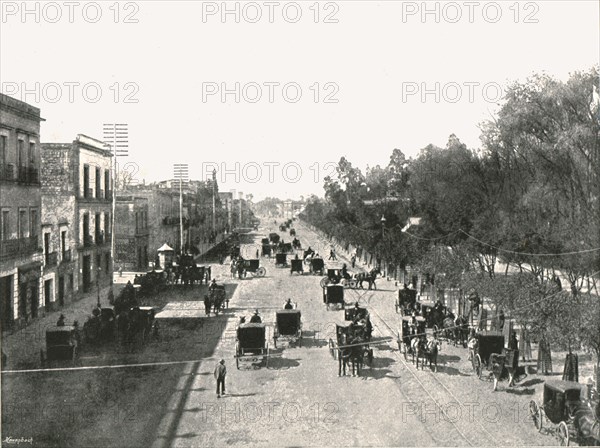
2;280;120;370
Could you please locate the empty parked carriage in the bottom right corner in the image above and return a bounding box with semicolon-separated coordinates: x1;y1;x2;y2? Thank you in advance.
529;380;600;446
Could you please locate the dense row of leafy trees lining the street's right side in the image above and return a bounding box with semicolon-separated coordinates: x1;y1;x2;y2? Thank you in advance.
303;68;600;368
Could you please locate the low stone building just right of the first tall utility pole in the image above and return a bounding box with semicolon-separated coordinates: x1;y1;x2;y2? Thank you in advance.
115;196;149;271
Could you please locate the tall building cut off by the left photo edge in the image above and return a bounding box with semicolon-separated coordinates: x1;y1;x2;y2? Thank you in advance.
0;94;44;330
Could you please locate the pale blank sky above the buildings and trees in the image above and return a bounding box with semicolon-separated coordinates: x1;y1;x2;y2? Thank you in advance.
0;0;600;200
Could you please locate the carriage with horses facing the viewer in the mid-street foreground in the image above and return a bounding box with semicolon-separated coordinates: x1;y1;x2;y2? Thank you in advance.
329;323;373;376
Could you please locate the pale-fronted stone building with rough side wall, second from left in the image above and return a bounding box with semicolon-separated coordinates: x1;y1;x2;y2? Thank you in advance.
42;134;113;303
